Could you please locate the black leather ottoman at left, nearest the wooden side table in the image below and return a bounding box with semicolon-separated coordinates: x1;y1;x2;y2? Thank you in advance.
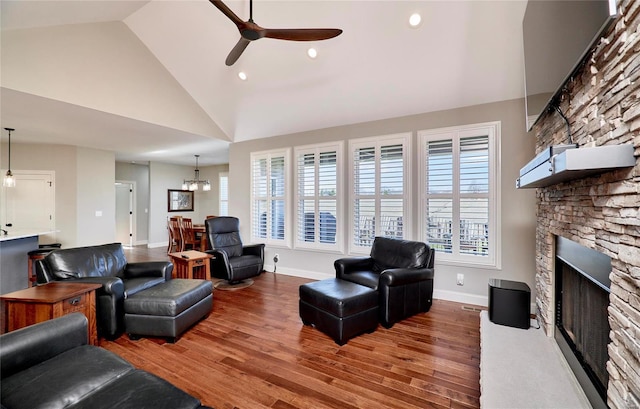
124;278;213;342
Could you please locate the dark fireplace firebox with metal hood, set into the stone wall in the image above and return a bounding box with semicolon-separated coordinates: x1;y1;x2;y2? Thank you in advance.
554;236;611;408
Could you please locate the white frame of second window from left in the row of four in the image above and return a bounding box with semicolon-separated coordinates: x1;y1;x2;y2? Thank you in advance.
292;141;344;254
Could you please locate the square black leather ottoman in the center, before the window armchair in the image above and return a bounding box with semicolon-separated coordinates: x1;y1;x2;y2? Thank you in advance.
300;278;378;345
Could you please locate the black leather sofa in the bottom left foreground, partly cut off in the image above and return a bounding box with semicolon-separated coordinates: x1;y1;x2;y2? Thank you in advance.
0;313;211;409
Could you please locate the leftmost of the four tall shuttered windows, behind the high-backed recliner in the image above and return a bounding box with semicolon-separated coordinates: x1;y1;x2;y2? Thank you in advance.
251;150;289;245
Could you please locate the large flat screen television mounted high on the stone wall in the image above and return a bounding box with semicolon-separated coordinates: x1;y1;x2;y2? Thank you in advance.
522;0;617;131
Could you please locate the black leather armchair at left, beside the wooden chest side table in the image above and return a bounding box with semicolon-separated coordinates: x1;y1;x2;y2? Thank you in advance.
36;243;173;339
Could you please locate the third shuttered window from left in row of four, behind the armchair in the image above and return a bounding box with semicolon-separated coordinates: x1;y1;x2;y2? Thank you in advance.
349;134;411;253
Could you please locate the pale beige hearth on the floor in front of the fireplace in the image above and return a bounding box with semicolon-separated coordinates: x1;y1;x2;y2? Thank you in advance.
480;311;591;409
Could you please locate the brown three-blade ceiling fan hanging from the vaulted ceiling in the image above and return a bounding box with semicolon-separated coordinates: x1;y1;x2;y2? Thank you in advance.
209;0;342;66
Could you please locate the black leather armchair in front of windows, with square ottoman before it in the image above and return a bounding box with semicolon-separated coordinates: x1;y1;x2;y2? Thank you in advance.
334;237;434;328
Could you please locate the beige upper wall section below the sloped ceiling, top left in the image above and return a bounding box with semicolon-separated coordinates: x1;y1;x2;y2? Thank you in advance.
1;22;226;139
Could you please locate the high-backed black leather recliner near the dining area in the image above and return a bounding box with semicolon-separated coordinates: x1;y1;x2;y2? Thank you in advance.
204;216;264;284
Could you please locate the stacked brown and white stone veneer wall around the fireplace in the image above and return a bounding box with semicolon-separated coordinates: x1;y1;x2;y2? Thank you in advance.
533;0;640;408
